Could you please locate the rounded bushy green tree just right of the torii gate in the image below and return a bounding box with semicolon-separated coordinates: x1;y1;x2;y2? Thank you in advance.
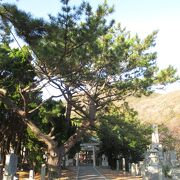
97;103;151;168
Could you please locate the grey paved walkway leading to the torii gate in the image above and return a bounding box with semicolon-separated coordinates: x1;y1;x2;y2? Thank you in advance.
76;166;107;180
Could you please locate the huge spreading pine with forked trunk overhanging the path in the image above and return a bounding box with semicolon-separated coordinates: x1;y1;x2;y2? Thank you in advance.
0;0;177;177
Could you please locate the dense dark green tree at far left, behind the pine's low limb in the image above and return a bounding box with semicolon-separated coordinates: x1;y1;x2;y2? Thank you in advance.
0;43;46;169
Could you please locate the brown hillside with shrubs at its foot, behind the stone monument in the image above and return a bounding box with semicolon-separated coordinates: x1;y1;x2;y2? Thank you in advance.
128;91;180;153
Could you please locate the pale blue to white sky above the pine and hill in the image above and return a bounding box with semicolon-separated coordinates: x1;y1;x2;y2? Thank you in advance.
2;0;180;90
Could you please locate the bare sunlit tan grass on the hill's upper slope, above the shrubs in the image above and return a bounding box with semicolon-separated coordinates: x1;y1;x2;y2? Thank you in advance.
128;91;180;125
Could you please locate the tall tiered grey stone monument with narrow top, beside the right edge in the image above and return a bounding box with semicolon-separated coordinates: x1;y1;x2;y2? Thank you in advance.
142;125;180;180
